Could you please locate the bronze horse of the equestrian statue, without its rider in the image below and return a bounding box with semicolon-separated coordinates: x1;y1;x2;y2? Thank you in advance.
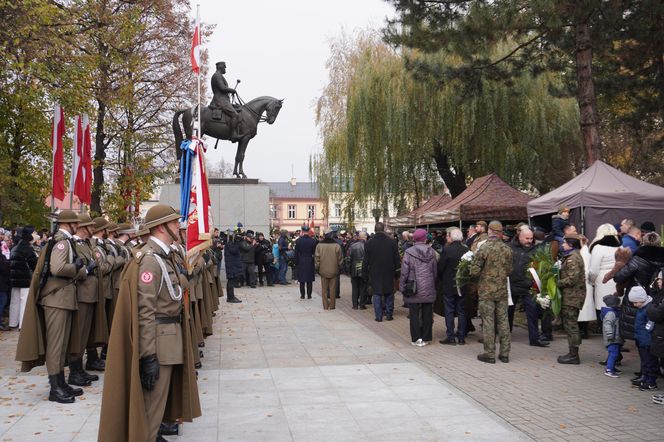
173;96;284;178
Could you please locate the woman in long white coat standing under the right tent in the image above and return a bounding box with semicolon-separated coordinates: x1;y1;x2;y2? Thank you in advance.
588;224;620;328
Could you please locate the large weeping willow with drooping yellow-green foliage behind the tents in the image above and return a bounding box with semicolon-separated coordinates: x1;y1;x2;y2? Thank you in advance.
312;32;583;218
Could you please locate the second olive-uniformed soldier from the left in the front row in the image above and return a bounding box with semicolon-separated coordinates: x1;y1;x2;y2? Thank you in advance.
68;213;99;387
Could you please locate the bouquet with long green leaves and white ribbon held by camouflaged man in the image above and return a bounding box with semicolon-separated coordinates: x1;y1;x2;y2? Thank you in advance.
528;244;562;317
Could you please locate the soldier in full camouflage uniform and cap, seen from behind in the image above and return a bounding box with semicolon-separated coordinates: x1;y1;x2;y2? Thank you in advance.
470;221;512;364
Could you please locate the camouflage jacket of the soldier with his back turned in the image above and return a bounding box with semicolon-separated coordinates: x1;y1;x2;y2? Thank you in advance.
469;237;512;301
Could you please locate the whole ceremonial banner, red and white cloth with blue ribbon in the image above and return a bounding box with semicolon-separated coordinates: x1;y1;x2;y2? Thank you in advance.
180;138;213;268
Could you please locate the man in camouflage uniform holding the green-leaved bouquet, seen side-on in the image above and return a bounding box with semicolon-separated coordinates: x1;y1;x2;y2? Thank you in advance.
558;233;586;364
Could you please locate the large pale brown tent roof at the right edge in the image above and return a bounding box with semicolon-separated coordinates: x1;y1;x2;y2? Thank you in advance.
528;161;664;216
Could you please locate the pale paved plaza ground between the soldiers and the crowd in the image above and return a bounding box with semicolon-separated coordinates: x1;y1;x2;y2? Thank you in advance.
0;278;664;441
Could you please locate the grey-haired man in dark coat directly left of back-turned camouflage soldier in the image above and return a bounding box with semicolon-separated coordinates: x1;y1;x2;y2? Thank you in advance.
438;227;469;345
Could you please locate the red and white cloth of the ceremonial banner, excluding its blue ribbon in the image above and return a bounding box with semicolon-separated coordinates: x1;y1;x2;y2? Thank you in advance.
187;138;213;268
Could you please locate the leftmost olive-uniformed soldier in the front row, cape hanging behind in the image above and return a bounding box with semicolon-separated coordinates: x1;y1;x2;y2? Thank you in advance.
39;210;87;403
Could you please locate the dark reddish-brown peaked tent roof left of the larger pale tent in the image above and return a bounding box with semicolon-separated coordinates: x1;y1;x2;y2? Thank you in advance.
422;173;532;224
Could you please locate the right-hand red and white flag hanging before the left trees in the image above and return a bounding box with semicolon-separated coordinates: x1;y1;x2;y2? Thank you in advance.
69;114;92;205
